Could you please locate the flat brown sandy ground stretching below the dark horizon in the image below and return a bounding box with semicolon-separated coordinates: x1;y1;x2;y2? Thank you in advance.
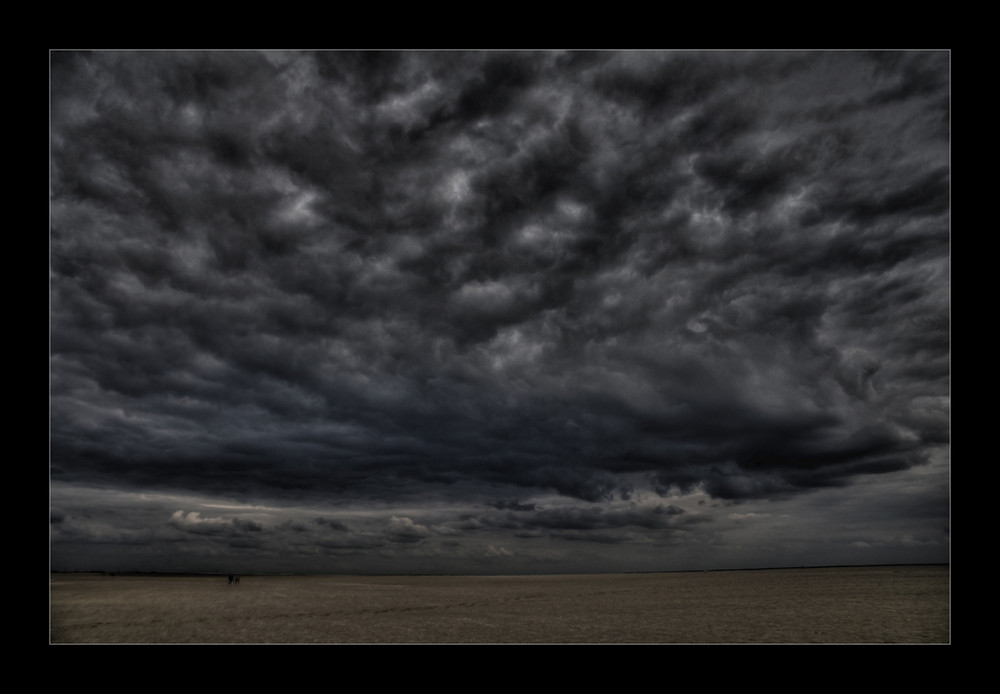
50;566;950;644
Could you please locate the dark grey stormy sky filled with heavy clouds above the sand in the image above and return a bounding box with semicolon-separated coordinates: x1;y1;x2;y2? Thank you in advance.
50;51;950;573
